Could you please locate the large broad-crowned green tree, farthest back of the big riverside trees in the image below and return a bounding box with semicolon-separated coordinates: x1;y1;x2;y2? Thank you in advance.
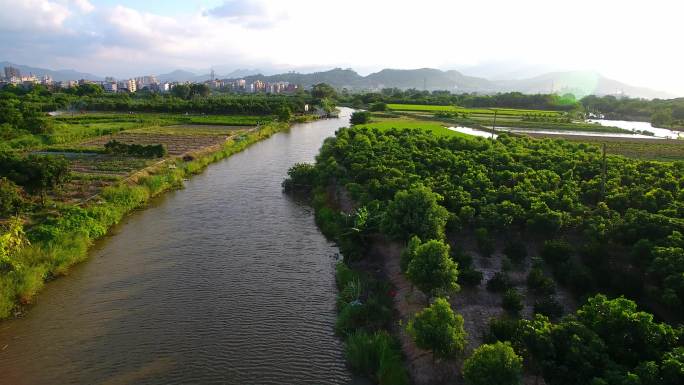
380;185;449;239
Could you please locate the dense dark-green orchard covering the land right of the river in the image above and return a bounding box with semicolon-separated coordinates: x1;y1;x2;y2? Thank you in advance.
286;126;684;385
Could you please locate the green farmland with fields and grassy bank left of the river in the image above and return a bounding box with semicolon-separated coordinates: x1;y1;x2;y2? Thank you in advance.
0;83;330;319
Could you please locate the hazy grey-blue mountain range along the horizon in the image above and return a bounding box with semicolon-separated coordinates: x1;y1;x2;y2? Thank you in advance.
0;62;674;99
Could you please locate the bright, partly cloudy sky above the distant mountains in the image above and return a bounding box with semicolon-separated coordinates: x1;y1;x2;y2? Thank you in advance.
0;0;684;96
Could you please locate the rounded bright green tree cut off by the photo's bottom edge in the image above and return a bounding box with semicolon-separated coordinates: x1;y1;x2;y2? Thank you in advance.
463;342;522;385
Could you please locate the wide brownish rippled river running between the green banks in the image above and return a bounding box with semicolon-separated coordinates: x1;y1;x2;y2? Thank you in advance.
0;109;360;385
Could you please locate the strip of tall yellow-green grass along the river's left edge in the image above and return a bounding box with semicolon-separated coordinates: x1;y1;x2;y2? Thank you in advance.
0;123;288;319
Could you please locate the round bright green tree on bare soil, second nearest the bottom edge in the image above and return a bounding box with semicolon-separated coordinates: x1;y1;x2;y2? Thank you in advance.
406;298;467;359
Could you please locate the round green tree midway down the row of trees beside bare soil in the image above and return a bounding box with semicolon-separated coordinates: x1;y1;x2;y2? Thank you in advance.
406;239;459;296
